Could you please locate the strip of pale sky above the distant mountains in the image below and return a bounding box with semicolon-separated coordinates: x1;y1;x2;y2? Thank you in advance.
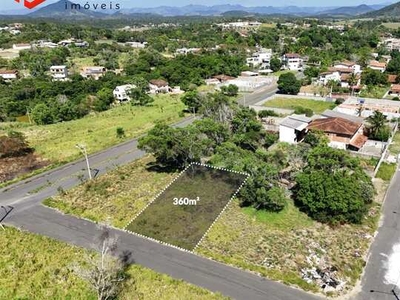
0;0;396;10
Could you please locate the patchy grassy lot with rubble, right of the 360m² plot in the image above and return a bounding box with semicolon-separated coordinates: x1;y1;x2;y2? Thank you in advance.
196;201;379;291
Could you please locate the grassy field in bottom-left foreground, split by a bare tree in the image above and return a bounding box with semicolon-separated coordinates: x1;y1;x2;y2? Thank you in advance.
0;228;225;300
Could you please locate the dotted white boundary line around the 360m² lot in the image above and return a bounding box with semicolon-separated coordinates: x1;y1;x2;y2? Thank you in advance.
123;162;250;254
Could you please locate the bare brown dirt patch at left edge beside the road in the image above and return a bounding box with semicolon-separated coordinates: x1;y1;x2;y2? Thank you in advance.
0;153;49;183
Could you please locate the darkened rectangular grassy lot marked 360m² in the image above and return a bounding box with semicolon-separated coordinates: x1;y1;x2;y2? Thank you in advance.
126;165;246;250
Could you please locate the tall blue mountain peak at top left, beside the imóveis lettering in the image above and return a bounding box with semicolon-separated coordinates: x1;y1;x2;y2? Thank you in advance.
28;0;106;18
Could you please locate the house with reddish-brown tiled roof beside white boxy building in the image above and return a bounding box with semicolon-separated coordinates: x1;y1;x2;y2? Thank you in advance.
307;117;368;151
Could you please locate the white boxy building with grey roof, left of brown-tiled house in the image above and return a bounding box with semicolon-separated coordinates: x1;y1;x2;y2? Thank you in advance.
279;114;311;144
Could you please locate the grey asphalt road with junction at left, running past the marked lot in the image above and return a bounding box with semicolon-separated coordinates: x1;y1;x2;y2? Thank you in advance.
0;88;319;300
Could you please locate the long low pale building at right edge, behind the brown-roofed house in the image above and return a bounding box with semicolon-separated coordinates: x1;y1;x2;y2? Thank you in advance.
334;98;400;120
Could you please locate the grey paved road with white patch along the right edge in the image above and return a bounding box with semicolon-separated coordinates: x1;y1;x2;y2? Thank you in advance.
356;165;400;300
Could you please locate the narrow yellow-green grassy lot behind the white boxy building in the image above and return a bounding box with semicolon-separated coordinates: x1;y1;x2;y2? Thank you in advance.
264;97;335;114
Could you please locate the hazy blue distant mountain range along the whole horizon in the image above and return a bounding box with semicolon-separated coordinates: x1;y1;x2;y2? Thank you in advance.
0;0;400;19
